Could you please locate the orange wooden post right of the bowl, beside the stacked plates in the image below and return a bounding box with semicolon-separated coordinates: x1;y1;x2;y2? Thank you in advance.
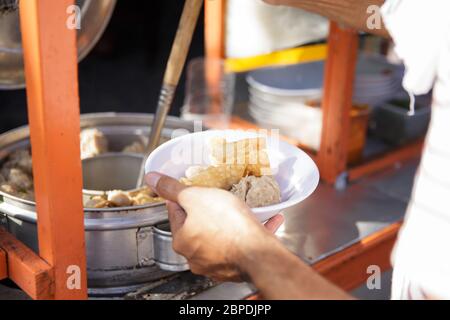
318;22;358;183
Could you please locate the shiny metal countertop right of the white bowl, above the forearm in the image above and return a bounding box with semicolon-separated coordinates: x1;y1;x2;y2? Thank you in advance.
277;178;407;264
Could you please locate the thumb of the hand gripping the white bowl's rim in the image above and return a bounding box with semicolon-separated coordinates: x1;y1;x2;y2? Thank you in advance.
145;172;187;202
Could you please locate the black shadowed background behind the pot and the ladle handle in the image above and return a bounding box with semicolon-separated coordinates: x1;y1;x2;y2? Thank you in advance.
0;0;204;132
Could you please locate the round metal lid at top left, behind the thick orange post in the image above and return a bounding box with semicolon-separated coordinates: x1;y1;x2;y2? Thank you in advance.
0;0;116;89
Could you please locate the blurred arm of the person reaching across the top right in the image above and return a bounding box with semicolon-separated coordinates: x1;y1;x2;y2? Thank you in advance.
263;0;389;37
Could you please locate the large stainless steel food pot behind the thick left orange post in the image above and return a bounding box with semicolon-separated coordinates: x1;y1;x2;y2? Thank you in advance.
0;113;194;294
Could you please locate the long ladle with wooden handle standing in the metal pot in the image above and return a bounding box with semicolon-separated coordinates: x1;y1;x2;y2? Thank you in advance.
137;0;204;188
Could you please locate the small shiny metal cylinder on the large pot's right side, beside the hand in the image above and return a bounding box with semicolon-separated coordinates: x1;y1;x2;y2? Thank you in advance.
153;223;189;272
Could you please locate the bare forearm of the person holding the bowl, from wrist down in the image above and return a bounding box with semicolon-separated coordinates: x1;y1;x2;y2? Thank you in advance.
240;237;352;300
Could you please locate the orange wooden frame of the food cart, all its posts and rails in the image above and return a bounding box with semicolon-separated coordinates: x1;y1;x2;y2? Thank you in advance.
0;0;421;299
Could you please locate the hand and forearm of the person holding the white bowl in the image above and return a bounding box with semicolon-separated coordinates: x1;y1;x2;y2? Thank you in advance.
146;173;351;299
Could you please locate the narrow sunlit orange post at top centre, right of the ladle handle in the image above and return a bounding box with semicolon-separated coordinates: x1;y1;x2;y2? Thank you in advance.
205;0;227;59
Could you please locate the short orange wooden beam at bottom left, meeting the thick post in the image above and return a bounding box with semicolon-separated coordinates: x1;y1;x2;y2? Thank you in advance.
0;228;54;300
